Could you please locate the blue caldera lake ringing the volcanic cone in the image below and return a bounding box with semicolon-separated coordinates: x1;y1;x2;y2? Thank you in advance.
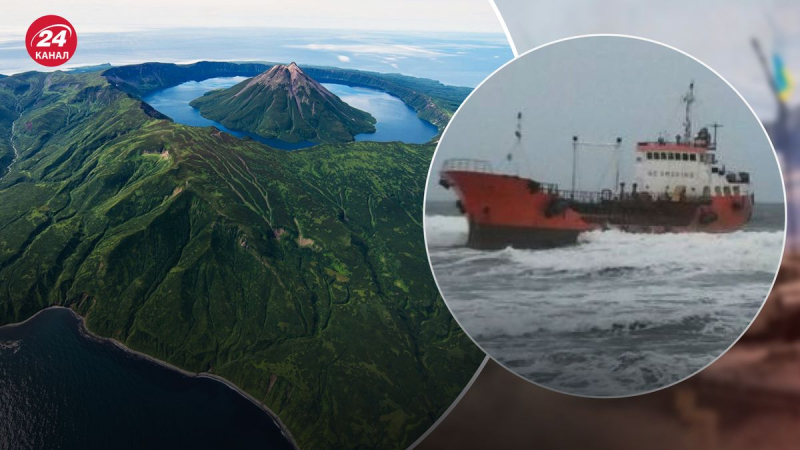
143;77;439;150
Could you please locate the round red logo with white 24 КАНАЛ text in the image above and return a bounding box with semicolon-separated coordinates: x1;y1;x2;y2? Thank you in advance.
25;16;78;67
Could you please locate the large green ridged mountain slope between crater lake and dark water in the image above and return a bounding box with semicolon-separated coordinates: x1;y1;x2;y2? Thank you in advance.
0;68;482;449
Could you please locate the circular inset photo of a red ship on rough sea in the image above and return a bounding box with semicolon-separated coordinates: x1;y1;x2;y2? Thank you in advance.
424;36;785;397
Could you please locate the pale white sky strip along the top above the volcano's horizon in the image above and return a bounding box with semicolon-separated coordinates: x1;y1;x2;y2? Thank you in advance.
0;0;501;33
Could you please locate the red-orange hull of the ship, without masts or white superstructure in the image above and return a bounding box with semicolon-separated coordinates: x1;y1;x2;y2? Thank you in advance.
440;170;753;249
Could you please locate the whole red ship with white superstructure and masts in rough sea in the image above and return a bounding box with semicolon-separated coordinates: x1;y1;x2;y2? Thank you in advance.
439;84;755;249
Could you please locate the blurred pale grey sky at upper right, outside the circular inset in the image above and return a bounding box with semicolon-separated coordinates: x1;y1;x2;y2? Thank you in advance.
495;0;800;119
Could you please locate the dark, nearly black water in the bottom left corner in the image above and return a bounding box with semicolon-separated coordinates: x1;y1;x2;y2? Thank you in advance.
0;308;292;450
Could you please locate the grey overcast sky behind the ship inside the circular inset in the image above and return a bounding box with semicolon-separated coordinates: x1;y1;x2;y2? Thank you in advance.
428;37;783;202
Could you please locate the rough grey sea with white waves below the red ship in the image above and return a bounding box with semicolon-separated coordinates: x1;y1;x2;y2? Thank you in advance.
425;205;784;396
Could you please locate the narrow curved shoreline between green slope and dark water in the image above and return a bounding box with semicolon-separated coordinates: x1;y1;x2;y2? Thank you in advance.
0;305;300;450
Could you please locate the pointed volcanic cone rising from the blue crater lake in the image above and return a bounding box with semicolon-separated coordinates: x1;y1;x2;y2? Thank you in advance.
191;63;375;142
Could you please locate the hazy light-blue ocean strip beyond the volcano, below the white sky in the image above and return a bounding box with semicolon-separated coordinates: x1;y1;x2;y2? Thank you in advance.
0;25;513;87
